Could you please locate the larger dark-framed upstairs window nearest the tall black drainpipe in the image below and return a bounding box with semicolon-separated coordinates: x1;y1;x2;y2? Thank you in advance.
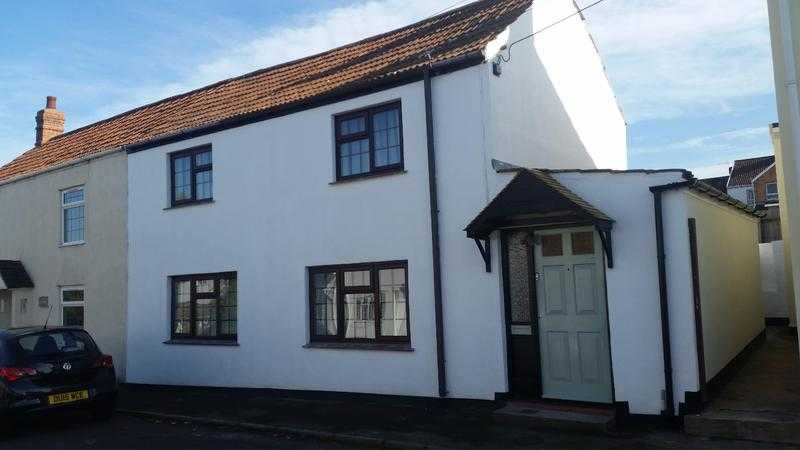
335;102;403;180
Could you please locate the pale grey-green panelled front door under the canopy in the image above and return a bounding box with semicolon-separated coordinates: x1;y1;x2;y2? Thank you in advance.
534;227;612;403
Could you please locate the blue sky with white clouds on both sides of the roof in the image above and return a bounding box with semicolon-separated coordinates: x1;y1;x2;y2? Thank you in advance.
0;0;777;176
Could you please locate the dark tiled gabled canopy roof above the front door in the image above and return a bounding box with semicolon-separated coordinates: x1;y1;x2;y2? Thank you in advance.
464;169;614;239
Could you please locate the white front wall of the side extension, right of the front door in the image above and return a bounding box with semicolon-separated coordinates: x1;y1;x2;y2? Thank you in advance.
556;171;682;414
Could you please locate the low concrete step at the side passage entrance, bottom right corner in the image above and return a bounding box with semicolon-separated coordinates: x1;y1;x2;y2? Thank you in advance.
683;410;800;444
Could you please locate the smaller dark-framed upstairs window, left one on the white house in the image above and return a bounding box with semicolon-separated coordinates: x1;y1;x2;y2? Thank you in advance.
170;145;213;206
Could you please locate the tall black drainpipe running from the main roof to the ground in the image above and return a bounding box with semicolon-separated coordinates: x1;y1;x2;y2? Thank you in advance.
424;69;447;397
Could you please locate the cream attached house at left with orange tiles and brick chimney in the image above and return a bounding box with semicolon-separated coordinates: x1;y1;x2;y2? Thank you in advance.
0;97;128;378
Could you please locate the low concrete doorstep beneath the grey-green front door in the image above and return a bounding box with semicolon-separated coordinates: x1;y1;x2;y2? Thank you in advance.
494;401;614;433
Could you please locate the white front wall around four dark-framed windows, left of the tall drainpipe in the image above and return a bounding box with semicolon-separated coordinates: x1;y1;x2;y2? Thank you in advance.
128;81;446;396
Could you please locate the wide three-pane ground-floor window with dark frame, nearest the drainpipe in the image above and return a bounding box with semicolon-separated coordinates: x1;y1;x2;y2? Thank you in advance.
309;261;409;342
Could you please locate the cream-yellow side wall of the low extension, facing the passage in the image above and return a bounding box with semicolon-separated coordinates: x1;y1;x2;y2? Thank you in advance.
685;191;764;379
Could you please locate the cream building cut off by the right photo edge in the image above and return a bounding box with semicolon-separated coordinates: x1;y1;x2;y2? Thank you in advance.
767;0;800;342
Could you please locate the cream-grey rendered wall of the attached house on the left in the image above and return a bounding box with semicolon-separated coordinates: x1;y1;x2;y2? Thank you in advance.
0;152;128;378
